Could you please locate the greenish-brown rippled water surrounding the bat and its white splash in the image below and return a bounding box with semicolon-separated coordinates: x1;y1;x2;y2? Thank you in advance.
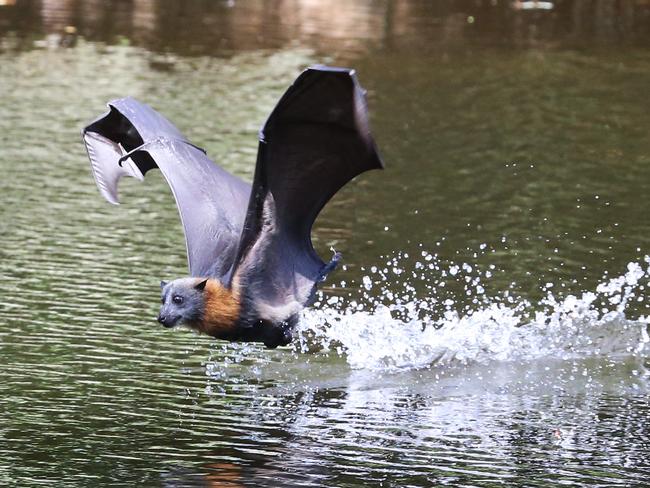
0;0;650;486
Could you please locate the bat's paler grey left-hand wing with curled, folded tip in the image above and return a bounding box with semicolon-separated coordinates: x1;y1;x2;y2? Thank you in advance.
83;98;251;282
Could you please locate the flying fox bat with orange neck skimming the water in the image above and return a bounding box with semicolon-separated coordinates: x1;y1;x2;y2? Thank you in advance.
83;66;383;348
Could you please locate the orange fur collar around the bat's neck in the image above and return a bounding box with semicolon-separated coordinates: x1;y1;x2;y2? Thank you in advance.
195;279;241;338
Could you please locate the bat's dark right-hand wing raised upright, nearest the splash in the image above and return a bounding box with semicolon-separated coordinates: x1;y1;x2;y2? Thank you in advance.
232;66;383;322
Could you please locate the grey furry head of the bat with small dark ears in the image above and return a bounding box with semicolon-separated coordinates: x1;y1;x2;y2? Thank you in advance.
158;278;208;327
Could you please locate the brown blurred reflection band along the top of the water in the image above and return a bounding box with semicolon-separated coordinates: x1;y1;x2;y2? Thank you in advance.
0;0;650;59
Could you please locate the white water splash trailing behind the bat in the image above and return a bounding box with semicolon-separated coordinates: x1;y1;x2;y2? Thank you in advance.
296;252;650;370
